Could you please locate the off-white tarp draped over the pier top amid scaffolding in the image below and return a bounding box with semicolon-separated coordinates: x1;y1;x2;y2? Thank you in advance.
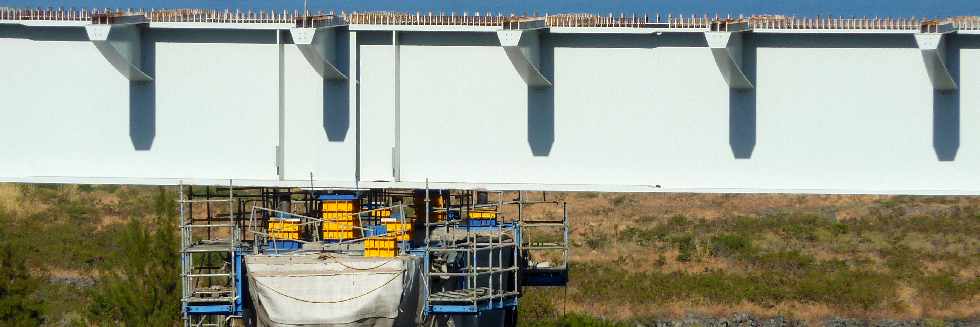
245;253;421;327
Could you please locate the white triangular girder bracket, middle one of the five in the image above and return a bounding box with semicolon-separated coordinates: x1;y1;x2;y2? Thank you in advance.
497;30;551;87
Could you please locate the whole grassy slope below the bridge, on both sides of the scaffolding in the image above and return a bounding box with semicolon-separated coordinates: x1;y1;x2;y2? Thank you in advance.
0;184;980;324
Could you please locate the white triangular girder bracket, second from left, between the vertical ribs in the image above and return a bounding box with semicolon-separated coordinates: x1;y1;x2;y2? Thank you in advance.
289;27;347;79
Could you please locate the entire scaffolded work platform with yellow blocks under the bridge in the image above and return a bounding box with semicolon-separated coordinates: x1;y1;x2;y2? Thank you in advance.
179;185;568;326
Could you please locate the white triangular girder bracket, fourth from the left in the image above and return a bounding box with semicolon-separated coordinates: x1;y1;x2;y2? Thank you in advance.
704;32;753;89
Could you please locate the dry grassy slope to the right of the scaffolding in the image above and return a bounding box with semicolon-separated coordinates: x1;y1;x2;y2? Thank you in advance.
524;193;980;321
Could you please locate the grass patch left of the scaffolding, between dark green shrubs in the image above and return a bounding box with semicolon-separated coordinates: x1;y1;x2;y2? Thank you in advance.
0;184;178;325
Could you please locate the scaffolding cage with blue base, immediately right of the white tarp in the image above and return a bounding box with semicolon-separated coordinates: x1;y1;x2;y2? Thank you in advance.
423;188;520;314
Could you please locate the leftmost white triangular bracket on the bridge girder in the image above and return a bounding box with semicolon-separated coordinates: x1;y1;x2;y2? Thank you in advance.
85;15;153;82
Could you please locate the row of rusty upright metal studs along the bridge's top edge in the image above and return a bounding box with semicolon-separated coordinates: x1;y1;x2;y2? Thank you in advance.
0;8;980;33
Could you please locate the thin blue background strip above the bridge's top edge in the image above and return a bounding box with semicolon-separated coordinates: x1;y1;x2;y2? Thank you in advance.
0;0;980;17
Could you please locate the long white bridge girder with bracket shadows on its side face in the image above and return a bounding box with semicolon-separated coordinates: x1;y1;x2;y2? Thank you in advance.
0;10;980;194
